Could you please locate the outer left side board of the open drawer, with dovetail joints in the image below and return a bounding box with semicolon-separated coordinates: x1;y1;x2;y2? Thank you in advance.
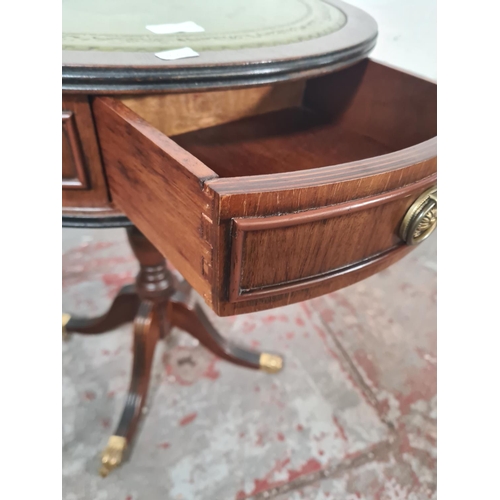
93;97;216;303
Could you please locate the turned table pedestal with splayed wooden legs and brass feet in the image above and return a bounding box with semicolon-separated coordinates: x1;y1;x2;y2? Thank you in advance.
63;227;283;476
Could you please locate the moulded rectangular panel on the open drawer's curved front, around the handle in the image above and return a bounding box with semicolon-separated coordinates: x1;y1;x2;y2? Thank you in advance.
229;176;435;302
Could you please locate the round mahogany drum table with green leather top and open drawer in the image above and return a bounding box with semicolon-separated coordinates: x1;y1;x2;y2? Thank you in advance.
62;0;437;475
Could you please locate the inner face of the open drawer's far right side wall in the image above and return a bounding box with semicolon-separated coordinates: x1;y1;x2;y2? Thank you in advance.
304;59;437;151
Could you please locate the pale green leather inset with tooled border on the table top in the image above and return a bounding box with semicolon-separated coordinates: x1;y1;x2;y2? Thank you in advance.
62;0;347;52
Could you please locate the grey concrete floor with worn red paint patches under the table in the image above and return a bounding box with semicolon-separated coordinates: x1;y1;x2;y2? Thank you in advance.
63;229;436;500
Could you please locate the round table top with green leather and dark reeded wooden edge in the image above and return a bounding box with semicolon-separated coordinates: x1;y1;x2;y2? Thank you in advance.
62;0;377;93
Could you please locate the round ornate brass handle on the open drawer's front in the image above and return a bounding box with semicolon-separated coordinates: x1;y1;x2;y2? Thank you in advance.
399;186;437;245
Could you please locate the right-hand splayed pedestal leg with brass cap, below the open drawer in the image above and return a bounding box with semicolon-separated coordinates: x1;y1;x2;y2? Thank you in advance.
168;302;283;373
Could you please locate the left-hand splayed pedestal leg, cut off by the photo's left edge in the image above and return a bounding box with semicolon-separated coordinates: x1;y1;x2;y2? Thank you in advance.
63;285;140;336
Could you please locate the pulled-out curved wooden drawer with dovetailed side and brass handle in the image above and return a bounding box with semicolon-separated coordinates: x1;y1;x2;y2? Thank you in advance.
93;60;437;316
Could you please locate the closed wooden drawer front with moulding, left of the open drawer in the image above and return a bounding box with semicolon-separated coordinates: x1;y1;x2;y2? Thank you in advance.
62;95;109;207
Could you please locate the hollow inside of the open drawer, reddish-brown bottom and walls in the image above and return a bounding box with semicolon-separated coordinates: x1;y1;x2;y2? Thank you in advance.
123;60;436;177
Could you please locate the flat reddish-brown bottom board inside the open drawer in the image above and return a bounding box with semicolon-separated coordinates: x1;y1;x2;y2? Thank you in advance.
173;106;394;177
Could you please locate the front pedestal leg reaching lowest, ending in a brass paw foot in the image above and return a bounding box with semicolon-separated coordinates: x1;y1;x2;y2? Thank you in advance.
100;300;166;477
